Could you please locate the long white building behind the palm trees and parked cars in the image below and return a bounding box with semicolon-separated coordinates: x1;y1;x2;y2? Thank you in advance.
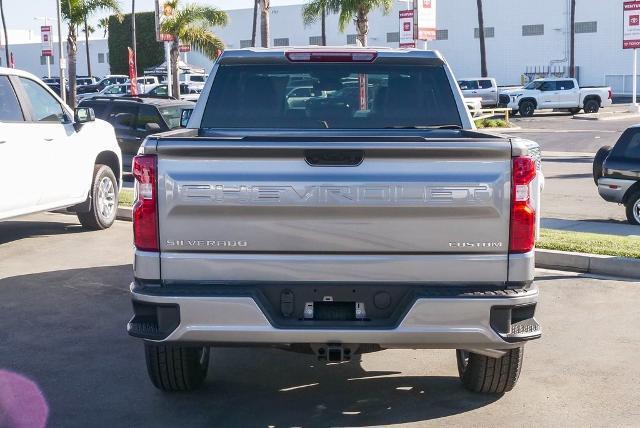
2;0;633;94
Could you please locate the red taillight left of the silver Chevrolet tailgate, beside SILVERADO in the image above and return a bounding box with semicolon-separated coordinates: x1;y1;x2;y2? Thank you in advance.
132;155;159;251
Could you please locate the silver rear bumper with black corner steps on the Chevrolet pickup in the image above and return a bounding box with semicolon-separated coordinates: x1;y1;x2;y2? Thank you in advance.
128;283;540;349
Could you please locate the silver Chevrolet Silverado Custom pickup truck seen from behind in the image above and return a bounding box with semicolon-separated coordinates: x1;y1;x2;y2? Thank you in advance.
128;48;540;393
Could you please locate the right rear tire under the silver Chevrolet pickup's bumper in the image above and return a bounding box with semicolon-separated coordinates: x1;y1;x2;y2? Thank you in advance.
456;348;524;394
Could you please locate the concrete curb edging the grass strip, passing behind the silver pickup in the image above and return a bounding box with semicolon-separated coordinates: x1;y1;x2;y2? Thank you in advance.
117;207;640;279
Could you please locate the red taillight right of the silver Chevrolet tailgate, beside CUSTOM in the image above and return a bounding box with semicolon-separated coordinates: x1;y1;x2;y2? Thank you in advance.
509;156;536;253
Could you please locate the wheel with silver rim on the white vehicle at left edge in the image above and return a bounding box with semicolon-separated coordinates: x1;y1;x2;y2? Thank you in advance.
78;164;118;230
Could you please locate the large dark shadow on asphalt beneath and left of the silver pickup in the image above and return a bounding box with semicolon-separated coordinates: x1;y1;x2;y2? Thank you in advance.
0;265;500;427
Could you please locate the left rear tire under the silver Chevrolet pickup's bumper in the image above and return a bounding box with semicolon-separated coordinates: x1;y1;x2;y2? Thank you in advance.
144;343;209;392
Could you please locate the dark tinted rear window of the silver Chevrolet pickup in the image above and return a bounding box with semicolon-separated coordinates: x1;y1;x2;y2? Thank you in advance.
202;63;461;129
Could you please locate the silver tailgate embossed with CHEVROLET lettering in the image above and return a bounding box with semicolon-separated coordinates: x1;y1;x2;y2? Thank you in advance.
156;138;511;282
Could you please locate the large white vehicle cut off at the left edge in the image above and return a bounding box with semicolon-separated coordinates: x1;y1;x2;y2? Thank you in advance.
0;68;122;229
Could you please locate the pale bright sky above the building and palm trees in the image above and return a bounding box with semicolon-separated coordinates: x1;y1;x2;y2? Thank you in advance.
4;0;303;36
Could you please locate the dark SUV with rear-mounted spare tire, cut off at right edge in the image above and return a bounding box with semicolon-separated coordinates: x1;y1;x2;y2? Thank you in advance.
593;126;640;225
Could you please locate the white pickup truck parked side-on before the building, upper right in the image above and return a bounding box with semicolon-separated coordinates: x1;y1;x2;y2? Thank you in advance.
500;78;613;117
